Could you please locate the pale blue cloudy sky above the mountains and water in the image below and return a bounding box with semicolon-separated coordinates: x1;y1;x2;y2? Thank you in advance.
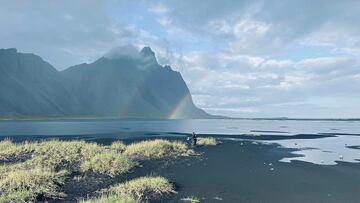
0;0;360;118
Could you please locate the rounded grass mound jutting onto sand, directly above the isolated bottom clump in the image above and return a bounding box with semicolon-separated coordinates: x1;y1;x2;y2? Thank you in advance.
81;153;137;177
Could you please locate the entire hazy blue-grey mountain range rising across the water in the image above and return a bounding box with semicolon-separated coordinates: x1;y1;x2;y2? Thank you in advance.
0;47;211;118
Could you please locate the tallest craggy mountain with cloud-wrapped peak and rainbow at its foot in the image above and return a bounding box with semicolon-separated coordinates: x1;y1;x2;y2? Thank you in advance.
62;47;209;118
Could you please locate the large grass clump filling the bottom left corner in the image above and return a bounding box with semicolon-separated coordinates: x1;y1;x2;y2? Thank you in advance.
0;168;66;202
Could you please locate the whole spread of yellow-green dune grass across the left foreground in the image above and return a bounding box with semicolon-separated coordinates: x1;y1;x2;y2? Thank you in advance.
0;139;193;203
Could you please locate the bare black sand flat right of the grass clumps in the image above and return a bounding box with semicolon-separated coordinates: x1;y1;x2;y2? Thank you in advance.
51;138;360;203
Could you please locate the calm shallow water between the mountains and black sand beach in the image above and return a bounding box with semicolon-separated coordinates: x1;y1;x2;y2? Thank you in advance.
0;119;360;165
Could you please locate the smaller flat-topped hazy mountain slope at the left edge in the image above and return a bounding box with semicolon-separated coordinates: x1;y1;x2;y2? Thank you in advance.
0;49;77;116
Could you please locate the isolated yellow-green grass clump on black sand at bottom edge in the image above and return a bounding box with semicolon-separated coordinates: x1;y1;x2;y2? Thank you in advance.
106;176;175;202
